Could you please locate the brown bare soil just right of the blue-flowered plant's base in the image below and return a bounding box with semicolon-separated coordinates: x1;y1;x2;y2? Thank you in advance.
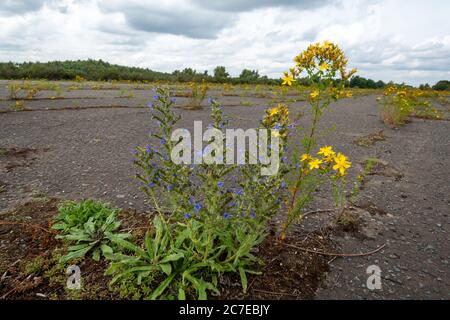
220;231;336;300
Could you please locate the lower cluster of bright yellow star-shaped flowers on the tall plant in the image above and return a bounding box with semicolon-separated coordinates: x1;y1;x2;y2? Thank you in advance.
300;146;352;177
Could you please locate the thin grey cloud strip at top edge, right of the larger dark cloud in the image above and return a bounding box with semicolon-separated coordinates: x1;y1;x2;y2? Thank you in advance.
193;0;331;12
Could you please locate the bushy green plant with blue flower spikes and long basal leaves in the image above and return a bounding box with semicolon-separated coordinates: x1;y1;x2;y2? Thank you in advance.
108;88;288;299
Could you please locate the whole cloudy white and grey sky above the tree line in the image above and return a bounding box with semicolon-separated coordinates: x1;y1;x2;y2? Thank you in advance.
0;0;450;84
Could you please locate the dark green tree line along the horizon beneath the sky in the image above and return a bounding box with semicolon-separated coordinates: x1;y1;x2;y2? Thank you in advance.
0;59;450;90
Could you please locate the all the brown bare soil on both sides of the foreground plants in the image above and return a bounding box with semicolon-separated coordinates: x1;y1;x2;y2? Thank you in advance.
0;199;336;299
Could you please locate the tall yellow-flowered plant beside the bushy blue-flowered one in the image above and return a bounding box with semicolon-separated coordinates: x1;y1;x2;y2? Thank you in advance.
281;41;356;239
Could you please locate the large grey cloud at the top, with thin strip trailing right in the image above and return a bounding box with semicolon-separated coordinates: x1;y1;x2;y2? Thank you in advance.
99;0;331;39
